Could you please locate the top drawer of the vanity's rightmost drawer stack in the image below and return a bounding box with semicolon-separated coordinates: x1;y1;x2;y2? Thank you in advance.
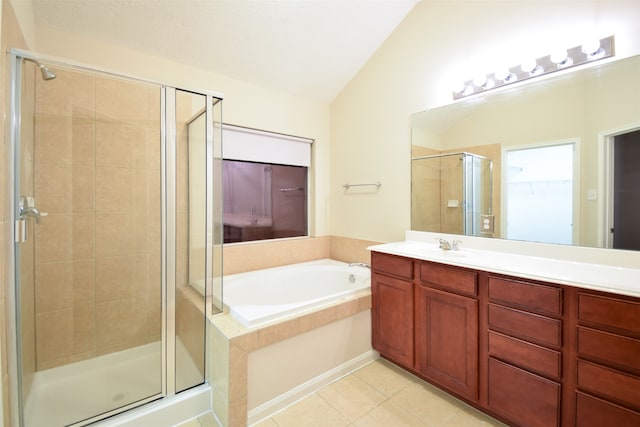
578;293;640;335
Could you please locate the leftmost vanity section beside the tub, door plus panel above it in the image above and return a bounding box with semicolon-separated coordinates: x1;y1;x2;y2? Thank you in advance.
371;252;414;369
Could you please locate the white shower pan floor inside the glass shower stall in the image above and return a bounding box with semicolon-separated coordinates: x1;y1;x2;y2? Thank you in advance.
25;340;202;427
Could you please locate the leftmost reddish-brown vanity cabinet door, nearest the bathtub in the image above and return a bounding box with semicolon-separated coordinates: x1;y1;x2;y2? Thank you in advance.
371;273;413;367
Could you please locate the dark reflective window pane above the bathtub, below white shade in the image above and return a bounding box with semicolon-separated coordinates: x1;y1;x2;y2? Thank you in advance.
222;159;307;243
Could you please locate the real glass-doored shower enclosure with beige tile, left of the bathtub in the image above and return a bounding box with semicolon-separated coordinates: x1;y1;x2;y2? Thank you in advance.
7;51;222;427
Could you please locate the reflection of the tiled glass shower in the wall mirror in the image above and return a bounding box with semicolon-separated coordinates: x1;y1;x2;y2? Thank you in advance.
411;153;493;236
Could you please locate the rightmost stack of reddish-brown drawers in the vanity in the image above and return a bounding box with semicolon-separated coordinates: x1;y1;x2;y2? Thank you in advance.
575;290;640;427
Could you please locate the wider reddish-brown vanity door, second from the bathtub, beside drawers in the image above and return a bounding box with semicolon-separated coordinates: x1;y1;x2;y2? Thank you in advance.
415;286;478;400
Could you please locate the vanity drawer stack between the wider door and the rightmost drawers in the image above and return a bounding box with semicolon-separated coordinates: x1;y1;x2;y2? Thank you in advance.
487;275;563;427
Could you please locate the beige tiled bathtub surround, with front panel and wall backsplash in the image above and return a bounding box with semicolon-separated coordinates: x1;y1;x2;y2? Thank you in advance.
208;236;376;426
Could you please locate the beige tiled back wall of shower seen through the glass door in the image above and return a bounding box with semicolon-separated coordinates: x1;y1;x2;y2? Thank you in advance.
34;69;161;370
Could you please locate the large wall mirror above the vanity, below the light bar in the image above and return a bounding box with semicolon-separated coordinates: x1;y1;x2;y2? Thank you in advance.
411;52;640;250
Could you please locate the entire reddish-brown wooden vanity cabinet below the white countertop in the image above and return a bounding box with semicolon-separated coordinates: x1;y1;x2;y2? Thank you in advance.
371;252;640;427
